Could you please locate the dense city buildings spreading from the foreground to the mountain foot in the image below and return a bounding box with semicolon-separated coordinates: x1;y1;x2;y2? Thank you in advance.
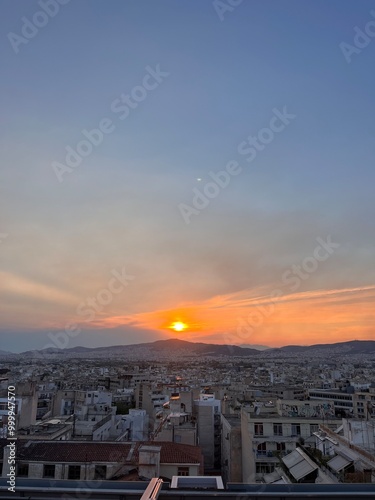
0;341;375;485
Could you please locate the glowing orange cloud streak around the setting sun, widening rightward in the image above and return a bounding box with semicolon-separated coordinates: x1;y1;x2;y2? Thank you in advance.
89;286;375;346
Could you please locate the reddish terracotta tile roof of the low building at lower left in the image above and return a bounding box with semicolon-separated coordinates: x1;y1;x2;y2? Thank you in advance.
5;440;203;465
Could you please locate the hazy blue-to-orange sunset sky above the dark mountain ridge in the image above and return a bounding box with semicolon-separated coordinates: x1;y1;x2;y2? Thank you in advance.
0;0;375;352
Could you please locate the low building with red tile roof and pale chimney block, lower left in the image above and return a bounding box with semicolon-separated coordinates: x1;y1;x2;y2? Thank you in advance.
0;439;203;481
